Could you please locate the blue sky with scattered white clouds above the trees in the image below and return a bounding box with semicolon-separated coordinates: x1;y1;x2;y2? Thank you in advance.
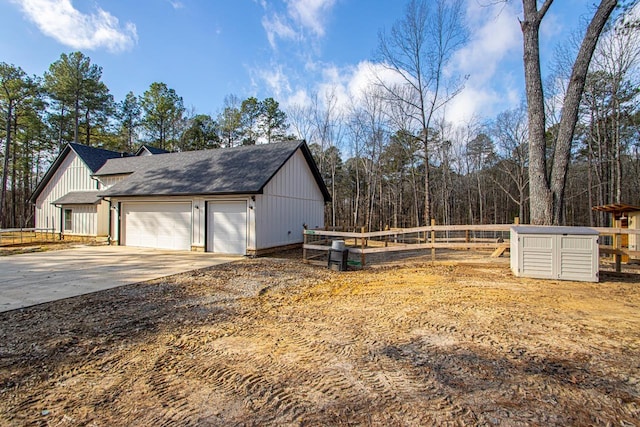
0;0;590;122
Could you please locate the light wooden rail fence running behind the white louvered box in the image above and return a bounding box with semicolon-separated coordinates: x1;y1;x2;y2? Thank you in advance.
303;222;640;271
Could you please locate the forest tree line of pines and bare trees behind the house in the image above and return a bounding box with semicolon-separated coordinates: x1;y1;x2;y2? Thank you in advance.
0;0;640;230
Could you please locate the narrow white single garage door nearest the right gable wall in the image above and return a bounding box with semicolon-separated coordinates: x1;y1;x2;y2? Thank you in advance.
207;201;247;255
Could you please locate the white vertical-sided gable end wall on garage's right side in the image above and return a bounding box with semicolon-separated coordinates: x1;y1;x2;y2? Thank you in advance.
255;150;324;250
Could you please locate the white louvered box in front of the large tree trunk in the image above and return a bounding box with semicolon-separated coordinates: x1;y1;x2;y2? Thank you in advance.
510;225;599;282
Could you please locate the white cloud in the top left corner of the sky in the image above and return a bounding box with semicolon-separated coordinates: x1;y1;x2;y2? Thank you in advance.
13;0;138;52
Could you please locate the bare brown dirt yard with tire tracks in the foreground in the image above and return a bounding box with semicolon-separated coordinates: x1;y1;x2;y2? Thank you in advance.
0;252;640;426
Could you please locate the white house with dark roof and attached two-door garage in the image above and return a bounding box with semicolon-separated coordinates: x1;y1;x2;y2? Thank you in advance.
32;141;330;254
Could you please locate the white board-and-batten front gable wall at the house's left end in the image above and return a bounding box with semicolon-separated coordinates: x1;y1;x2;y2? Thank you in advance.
36;150;99;236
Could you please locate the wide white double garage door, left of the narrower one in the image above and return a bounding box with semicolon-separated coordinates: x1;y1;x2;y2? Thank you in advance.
122;203;191;250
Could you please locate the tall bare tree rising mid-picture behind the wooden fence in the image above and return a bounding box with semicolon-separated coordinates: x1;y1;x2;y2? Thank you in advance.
378;0;467;227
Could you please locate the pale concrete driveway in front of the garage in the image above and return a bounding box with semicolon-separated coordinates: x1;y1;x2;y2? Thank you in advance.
0;246;241;312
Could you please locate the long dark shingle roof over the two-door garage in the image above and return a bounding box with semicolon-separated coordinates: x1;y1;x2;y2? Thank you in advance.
96;141;331;201
